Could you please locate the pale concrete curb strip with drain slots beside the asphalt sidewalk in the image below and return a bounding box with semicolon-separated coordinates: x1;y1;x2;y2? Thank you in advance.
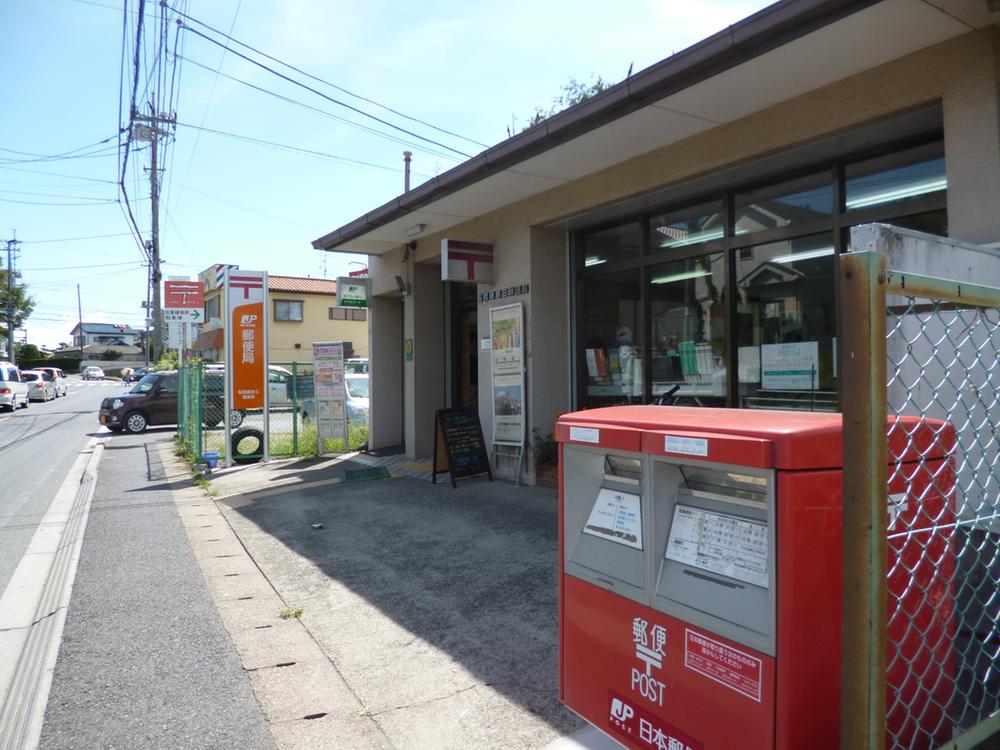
157;444;393;750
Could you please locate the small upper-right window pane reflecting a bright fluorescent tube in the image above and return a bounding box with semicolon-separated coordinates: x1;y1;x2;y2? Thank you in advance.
844;143;948;211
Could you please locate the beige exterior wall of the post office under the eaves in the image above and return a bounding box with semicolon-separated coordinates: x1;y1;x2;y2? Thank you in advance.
371;28;1000;470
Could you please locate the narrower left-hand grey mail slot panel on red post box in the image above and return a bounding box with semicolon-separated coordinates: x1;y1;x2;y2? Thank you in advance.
563;446;649;602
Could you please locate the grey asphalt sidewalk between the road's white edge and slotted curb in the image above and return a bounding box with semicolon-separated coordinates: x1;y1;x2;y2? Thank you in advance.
41;432;273;750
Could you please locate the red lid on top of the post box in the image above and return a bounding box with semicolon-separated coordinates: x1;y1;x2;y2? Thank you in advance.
556;405;955;470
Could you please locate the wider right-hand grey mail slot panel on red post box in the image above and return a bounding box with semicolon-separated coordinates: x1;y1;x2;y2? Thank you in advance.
650;461;776;654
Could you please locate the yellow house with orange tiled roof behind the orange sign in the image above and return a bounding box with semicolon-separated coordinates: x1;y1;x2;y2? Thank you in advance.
192;265;368;364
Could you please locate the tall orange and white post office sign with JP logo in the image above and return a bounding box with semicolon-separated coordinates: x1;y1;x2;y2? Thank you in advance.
226;270;267;409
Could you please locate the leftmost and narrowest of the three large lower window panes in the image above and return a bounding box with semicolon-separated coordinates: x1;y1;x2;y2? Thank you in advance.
581;271;643;406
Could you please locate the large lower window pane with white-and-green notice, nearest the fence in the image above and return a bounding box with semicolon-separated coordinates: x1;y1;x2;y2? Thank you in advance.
735;234;837;411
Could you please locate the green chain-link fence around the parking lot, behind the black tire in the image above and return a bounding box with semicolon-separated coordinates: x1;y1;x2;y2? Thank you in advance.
178;362;368;463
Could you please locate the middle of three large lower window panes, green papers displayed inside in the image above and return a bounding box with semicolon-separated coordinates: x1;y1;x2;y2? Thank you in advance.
649;253;726;406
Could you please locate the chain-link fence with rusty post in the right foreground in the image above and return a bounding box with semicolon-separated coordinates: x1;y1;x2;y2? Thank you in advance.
844;253;1000;750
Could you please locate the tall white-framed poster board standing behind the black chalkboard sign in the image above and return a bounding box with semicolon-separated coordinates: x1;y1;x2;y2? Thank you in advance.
490;302;524;445
